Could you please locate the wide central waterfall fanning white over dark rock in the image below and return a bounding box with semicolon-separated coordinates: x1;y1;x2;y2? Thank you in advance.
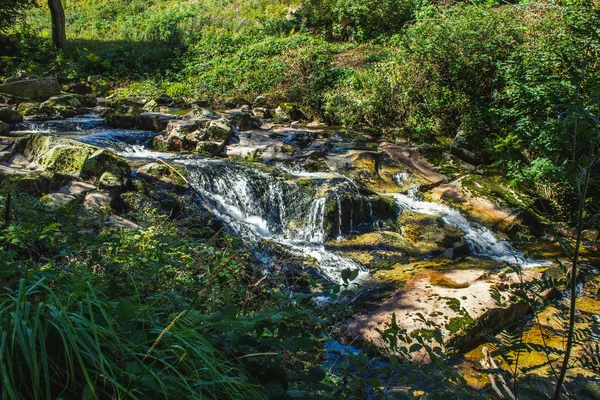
183;160;367;282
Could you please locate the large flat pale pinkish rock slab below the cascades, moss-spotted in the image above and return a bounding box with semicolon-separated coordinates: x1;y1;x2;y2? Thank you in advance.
346;269;533;358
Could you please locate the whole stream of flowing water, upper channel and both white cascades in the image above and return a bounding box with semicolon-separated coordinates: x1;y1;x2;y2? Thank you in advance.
13;115;548;282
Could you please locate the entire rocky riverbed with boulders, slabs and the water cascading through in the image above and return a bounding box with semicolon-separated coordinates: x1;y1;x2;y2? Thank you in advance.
0;82;600;394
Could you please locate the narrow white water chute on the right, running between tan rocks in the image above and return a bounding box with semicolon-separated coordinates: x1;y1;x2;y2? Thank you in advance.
393;173;549;268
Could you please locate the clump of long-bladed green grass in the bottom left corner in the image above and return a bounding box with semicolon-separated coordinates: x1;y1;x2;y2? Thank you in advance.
0;278;259;399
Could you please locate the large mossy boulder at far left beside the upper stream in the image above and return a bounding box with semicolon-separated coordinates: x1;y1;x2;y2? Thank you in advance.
25;134;131;183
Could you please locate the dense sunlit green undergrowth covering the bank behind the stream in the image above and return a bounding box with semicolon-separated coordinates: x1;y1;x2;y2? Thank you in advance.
0;0;600;216
